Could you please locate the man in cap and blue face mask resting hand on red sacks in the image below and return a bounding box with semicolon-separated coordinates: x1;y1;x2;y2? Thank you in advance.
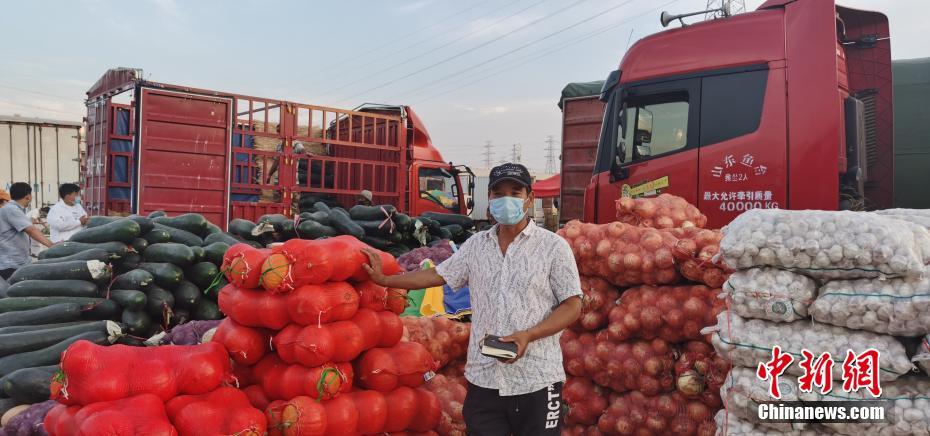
366;163;582;436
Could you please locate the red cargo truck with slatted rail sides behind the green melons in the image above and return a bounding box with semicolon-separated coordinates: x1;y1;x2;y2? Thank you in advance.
82;68;474;228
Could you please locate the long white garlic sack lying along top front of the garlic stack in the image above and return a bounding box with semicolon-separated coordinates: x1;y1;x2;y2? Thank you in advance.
720;209;930;279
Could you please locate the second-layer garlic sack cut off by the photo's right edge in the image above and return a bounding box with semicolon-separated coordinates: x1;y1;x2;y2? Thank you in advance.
809;278;930;336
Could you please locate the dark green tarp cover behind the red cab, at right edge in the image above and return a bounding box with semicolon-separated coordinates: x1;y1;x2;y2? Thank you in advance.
891;58;930;209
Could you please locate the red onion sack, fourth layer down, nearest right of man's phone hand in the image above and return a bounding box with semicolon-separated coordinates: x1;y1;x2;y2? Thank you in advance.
582;331;676;396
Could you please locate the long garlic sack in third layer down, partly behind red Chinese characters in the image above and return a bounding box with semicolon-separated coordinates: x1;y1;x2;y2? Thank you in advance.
701;311;914;382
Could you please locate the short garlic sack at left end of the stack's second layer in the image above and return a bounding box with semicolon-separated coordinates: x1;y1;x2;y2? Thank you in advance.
720;267;817;322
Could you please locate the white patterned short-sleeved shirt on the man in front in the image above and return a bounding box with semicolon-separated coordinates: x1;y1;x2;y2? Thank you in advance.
436;222;582;396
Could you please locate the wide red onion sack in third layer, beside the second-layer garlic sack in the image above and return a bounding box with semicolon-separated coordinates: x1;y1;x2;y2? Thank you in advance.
607;285;726;343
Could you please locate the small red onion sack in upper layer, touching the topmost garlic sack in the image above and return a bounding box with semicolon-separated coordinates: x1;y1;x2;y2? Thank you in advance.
669;227;733;288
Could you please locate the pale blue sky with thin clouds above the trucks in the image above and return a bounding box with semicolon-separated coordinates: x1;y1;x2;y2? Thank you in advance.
0;0;930;174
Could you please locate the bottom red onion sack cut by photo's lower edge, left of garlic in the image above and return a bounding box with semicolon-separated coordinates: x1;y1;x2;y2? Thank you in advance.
597;392;717;436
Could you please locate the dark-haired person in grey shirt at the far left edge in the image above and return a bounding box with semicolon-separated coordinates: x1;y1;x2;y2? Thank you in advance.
0;182;53;280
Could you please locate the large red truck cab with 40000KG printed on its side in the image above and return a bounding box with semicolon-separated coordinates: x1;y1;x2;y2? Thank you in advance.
584;0;894;227
